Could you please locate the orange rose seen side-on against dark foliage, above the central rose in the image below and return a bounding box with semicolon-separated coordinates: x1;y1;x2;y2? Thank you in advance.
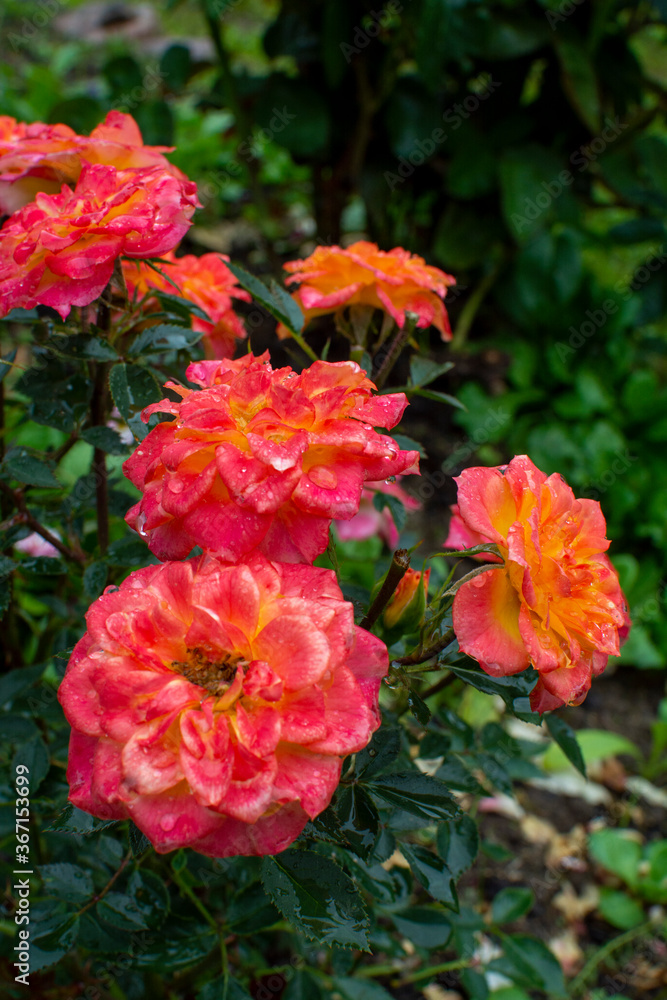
278;240;456;340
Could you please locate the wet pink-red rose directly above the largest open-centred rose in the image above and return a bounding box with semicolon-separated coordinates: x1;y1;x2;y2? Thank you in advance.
123;353;419;562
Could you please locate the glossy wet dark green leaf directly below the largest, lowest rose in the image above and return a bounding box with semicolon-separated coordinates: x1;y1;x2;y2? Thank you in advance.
262;848;368;951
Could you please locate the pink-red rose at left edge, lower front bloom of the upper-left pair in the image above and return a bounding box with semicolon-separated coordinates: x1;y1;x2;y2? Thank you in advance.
0;165;198;319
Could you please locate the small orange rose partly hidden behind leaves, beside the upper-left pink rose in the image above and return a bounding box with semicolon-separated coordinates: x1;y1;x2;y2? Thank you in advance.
123;253;251;358
